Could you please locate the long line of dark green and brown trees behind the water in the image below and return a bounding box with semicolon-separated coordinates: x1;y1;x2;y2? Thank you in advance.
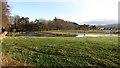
8;15;96;32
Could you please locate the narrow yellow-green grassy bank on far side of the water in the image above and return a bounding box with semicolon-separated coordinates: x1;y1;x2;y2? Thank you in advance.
42;30;118;34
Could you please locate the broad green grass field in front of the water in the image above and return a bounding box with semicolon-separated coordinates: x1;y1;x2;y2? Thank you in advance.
3;37;120;66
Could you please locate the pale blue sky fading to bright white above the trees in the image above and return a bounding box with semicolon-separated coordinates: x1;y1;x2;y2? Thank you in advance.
8;0;120;24
